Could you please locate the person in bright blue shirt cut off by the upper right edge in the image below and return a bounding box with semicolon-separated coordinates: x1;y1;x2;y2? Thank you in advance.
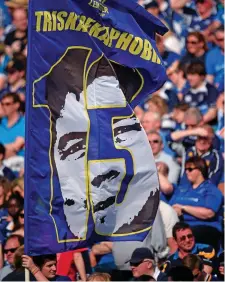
206;26;224;93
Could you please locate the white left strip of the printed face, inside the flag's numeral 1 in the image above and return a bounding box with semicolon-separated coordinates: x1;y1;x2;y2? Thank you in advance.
54;90;88;238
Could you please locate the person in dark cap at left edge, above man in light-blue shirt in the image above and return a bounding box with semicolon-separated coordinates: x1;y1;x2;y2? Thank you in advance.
1;55;26;101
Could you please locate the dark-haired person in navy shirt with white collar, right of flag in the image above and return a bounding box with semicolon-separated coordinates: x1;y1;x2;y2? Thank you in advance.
183;62;219;123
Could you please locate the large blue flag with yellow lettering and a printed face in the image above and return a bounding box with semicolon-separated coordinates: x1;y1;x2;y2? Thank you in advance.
25;0;166;255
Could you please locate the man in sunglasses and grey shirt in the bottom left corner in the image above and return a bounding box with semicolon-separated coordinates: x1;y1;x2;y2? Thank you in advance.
0;235;24;281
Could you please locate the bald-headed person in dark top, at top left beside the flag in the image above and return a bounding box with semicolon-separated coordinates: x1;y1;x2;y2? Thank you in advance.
4;7;28;56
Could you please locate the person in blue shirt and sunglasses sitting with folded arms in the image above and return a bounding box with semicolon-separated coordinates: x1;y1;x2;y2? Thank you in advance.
171;157;223;250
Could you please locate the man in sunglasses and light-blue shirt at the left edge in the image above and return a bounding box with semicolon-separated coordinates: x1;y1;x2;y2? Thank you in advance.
0;93;25;158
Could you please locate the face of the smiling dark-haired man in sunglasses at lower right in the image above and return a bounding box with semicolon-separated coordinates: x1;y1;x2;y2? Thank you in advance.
176;228;195;252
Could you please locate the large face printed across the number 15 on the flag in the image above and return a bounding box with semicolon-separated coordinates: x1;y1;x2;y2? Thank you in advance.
47;50;159;238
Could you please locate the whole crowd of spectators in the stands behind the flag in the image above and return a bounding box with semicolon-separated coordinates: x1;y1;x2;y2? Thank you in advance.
0;0;224;281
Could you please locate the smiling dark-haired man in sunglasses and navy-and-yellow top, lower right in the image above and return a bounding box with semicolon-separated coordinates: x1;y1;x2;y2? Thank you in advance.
162;222;216;274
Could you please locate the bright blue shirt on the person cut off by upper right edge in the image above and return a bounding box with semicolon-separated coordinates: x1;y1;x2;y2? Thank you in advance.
206;47;224;92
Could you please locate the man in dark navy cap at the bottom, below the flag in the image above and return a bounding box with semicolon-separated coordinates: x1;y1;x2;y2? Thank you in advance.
130;248;168;281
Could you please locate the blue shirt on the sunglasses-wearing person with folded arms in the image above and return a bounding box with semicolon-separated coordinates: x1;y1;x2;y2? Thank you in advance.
171;180;223;232
